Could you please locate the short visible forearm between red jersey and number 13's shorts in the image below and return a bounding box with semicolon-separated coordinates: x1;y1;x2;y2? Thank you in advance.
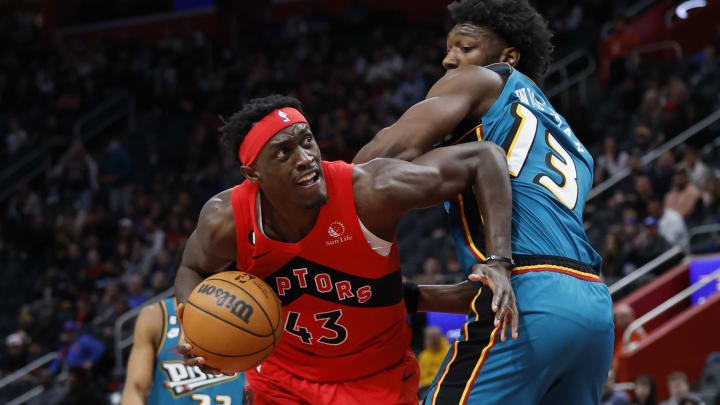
417;281;478;314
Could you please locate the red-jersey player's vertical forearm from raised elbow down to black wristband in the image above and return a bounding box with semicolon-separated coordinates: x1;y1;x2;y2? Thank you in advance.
475;142;512;257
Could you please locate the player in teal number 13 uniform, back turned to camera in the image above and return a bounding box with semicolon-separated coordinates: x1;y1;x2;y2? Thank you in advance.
355;0;613;405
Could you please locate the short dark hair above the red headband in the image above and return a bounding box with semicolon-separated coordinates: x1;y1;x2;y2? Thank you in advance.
220;94;303;163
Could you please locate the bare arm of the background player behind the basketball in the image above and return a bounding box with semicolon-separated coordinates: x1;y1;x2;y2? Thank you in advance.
121;303;163;405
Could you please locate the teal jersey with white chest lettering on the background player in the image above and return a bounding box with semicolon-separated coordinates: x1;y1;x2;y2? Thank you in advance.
148;298;245;405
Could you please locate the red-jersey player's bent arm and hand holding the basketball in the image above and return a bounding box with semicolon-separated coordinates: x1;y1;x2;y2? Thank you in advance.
175;190;237;374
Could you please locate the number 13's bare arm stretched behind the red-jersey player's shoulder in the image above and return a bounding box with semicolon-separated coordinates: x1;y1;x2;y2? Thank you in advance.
354;66;503;163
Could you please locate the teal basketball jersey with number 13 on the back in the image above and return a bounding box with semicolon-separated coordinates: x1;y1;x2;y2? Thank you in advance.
439;63;602;273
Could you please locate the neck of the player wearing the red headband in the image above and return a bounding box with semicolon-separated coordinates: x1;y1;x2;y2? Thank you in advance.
260;192;320;243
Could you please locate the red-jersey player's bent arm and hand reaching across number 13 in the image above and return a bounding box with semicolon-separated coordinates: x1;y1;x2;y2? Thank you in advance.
354;142;518;340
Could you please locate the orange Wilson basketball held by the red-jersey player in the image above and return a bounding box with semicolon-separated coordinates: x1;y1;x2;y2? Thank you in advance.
183;271;283;372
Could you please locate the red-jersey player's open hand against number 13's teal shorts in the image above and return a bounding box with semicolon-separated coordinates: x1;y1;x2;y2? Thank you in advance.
468;262;519;342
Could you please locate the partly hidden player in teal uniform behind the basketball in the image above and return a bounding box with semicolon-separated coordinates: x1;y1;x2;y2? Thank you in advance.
122;298;250;405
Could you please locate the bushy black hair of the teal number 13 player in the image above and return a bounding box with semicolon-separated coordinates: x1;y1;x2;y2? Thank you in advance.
448;0;554;82
